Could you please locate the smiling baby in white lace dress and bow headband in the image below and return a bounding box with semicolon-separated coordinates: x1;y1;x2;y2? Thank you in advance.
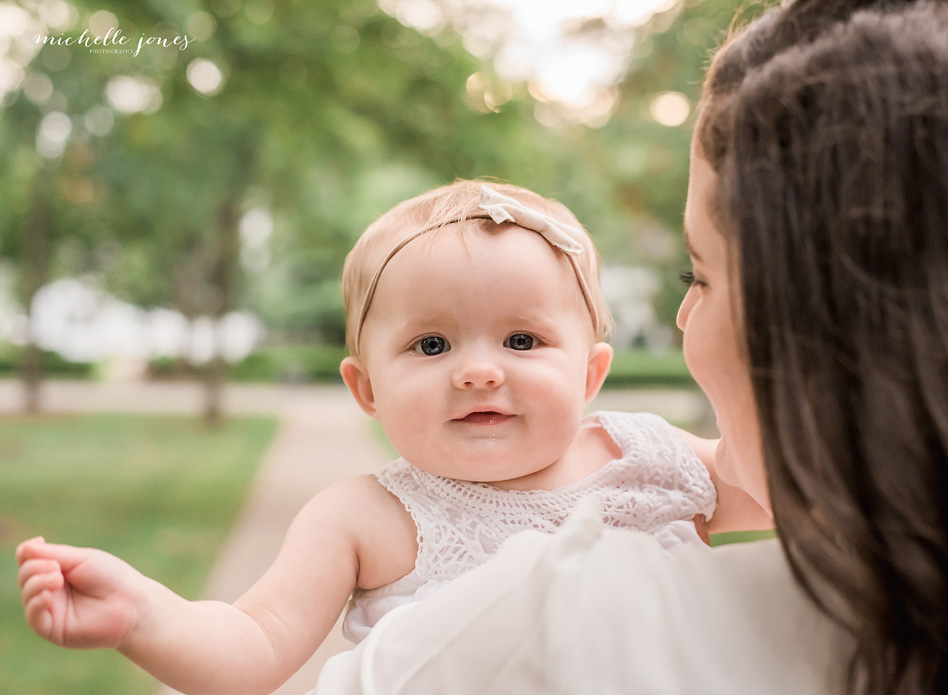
17;181;738;695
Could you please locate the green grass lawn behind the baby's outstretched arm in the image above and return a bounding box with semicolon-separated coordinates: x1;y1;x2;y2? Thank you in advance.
0;415;276;695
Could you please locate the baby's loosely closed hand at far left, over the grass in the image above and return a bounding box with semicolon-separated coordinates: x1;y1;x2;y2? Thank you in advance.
16;538;147;649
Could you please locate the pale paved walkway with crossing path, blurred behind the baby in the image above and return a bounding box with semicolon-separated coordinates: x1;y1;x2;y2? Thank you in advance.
0;381;709;695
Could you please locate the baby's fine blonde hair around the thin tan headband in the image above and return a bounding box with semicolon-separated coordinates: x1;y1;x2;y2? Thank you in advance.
342;181;613;356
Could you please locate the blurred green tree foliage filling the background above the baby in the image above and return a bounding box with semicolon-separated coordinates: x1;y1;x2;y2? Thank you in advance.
0;0;760;420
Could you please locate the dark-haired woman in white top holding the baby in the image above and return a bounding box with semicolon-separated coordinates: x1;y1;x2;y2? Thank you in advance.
317;0;948;695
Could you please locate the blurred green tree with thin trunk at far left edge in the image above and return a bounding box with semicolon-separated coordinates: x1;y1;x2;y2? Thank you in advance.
0;17;115;412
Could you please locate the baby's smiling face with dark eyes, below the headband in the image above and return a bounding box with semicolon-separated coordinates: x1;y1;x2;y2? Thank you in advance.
350;227;608;487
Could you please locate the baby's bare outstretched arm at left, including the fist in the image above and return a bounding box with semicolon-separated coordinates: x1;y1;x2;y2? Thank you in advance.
17;477;414;695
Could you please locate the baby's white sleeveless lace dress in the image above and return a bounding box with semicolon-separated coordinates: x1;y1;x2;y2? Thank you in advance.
343;412;716;642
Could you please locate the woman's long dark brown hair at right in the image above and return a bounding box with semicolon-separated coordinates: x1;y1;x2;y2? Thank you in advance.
696;0;948;695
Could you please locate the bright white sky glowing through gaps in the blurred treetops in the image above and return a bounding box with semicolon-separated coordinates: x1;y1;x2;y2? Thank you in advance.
0;0;687;128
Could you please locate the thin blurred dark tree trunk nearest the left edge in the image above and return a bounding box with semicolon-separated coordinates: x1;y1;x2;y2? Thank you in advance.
20;174;50;413
